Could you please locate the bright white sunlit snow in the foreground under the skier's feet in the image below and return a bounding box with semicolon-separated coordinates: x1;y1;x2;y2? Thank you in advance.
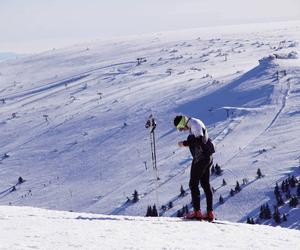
0;206;300;250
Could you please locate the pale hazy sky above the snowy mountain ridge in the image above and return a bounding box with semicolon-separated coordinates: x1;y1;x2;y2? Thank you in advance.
0;0;300;53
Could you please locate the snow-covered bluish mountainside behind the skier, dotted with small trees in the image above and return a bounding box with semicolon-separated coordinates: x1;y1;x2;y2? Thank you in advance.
0;22;300;229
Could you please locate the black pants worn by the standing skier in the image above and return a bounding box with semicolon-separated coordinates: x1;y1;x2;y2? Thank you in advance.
189;157;213;212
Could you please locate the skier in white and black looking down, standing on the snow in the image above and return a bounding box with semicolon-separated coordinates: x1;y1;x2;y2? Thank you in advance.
174;115;215;221
